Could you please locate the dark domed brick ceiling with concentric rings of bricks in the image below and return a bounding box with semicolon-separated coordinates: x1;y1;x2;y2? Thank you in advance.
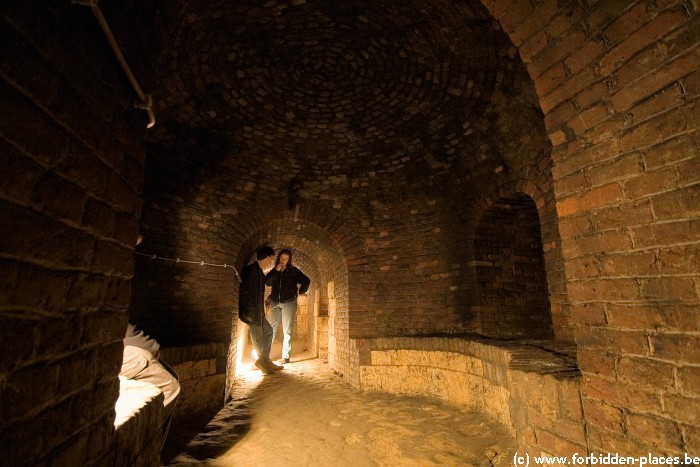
149;0;535;195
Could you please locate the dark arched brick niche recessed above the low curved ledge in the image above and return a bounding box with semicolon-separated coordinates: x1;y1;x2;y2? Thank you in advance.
474;193;553;338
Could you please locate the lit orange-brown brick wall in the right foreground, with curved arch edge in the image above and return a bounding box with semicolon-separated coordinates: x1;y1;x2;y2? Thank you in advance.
484;1;700;454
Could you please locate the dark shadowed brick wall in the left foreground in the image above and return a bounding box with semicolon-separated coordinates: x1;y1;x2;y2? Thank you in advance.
0;1;146;465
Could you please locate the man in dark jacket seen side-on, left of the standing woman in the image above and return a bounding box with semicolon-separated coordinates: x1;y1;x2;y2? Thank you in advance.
238;246;283;375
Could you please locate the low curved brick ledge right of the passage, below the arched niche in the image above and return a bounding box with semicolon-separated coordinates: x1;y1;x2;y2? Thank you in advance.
358;337;587;455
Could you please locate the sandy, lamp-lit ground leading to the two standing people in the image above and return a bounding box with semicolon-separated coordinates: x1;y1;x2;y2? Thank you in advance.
164;340;515;467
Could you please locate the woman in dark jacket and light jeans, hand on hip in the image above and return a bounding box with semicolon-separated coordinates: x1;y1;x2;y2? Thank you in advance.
265;248;311;363
